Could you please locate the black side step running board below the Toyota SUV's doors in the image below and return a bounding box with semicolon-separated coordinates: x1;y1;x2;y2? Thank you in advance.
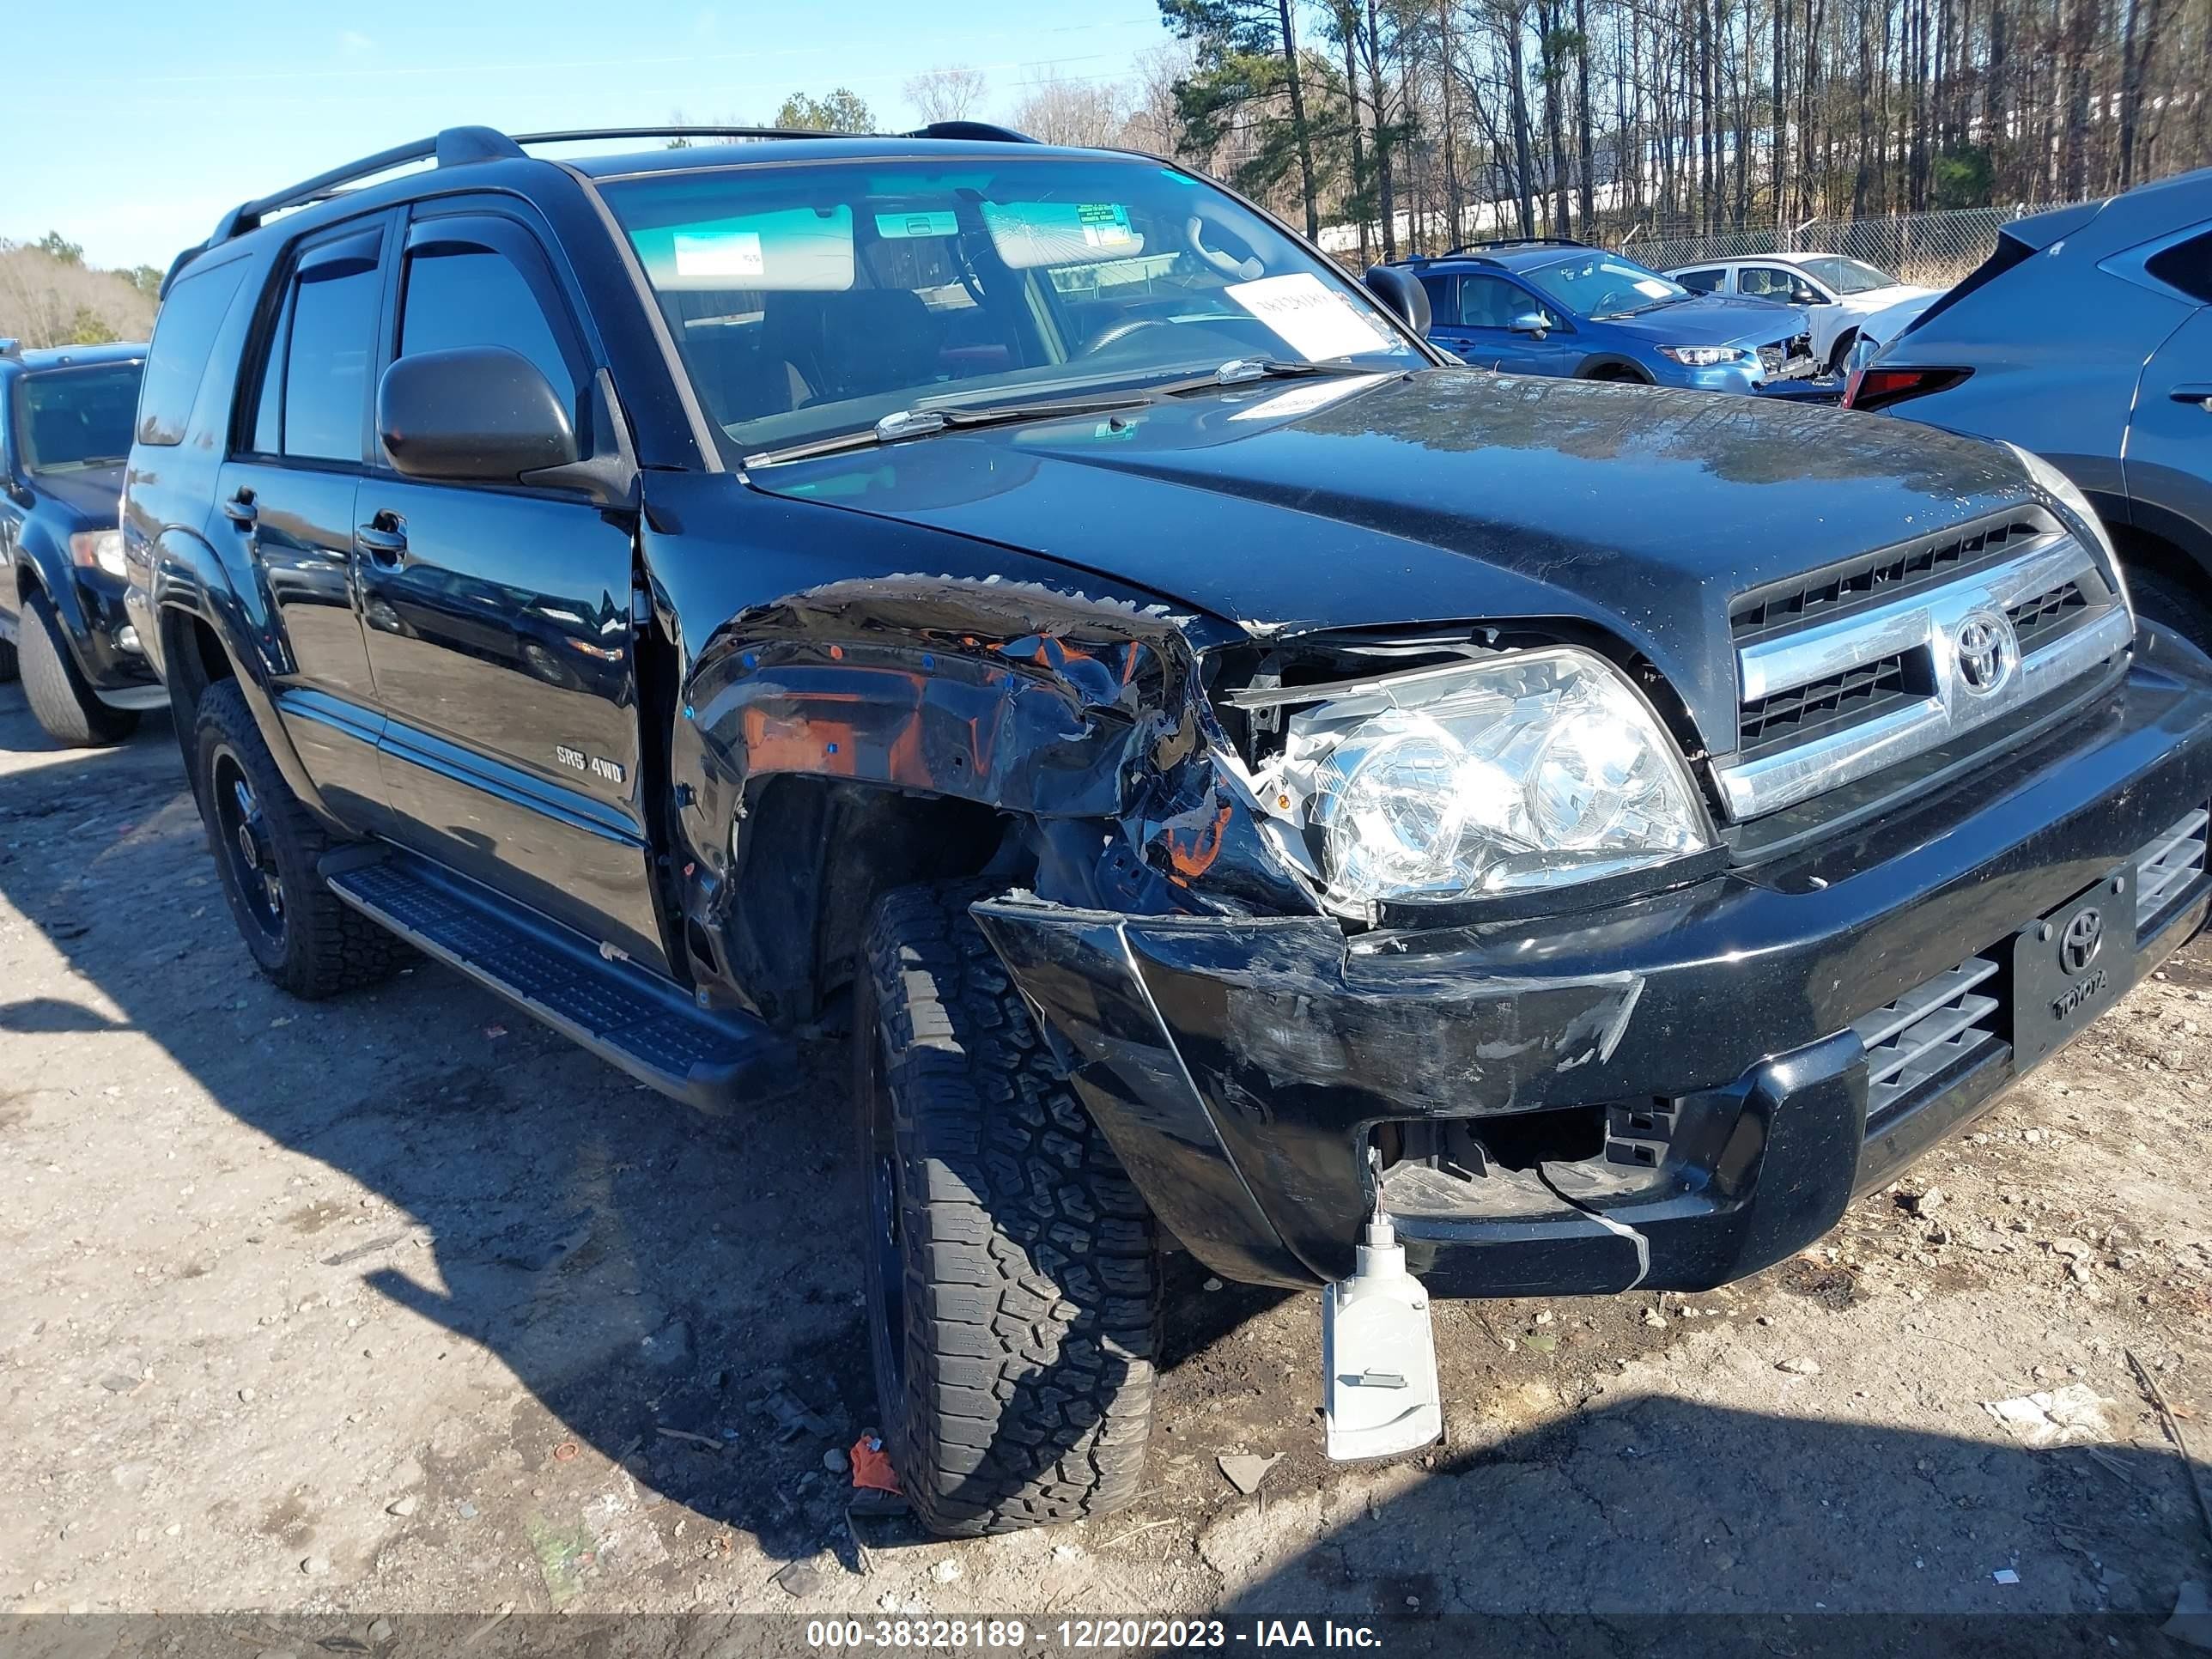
321;848;792;1113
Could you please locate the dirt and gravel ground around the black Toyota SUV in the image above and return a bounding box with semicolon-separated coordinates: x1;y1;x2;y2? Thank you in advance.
0;686;2212;1617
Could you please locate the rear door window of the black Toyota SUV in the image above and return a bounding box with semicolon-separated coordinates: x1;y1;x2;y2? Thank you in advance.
276;232;383;465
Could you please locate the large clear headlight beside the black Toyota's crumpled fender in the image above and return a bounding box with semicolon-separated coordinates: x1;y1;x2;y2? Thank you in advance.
1239;648;1712;914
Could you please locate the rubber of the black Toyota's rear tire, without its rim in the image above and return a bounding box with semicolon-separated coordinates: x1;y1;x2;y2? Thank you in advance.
192;679;410;1002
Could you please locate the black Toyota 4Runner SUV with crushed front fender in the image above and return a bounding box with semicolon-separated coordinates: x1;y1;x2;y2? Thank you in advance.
124;126;2212;1533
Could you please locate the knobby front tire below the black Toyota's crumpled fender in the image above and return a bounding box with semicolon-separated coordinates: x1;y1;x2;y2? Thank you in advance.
854;884;1159;1537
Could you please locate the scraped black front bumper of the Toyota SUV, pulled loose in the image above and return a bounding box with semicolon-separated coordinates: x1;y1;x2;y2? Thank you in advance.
975;648;2212;1297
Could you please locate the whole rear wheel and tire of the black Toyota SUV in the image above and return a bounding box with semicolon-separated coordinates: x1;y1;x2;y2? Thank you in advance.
192;679;407;1002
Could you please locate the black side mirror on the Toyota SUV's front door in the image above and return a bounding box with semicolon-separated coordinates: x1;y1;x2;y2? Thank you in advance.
376;345;577;484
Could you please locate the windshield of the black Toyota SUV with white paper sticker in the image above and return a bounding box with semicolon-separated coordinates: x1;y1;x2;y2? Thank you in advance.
606;155;1429;458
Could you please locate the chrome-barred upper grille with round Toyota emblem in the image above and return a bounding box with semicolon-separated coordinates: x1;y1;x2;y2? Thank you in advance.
1717;508;2135;821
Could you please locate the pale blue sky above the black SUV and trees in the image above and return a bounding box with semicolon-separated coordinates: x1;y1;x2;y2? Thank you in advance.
0;0;1168;265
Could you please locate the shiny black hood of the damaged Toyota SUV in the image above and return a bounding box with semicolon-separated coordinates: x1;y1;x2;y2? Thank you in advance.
750;369;2031;750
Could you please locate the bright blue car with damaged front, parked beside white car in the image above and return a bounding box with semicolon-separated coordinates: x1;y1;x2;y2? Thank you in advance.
1407;239;1820;392
